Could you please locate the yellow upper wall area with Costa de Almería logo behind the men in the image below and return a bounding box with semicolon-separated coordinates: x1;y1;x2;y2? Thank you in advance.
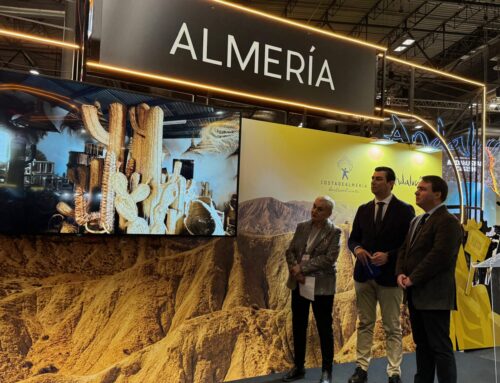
239;119;442;216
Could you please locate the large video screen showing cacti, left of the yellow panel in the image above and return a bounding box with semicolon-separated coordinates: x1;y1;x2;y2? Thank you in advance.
0;71;241;236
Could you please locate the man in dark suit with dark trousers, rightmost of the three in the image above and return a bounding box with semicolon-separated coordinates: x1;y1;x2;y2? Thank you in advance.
396;176;463;383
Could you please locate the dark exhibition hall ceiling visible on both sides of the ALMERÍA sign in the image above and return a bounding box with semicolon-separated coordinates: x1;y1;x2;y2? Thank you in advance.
0;0;500;136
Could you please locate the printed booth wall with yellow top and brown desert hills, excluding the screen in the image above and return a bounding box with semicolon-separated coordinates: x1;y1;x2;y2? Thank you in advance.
0;120;441;383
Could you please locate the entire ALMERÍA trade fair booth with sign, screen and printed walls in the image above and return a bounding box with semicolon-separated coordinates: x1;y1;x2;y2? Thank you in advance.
0;0;500;383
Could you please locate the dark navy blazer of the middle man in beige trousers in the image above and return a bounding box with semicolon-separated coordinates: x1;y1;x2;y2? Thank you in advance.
348;195;415;286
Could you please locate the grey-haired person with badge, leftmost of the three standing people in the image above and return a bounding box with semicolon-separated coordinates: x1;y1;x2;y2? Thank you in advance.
283;196;340;383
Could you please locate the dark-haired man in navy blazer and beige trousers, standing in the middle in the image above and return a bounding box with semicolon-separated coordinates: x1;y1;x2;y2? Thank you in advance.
348;166;415;383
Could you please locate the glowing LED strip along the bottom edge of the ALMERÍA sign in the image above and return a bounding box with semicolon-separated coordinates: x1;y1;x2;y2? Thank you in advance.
86;61;384;121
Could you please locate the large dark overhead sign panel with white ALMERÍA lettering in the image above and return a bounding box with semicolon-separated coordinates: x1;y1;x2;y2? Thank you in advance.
90;0;377;115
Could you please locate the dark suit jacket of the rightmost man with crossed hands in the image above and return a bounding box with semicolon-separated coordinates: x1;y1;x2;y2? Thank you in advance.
396;206;463;310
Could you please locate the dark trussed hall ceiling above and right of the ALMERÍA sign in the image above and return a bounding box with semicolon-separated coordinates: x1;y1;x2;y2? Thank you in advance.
234;0;500;75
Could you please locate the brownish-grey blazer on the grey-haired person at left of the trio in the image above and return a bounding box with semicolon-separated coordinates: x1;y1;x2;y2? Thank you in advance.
286;220;340;295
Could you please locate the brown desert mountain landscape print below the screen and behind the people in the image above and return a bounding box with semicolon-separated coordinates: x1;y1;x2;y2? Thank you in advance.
0;198;413;383
